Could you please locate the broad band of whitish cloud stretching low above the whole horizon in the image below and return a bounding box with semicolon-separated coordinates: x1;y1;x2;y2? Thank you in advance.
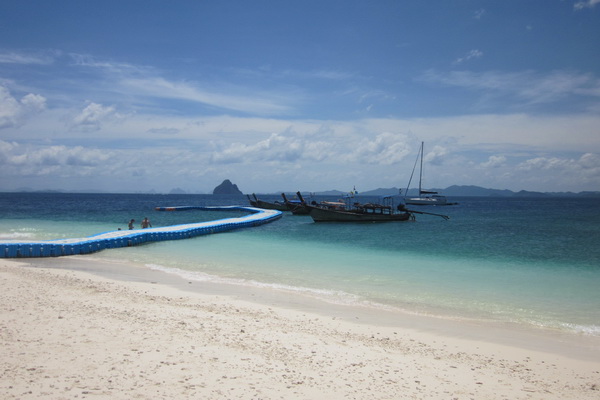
0;84;600;192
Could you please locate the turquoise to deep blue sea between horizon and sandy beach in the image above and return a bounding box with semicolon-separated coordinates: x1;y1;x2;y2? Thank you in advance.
0;193;600;336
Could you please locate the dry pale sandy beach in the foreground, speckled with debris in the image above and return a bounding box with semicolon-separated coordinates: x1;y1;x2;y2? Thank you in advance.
0;258;600;400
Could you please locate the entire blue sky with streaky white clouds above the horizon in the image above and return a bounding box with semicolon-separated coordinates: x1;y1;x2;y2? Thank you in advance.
0;0;600;193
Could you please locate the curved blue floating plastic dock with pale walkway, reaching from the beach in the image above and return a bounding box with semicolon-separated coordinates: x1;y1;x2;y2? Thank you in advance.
0;206;282;258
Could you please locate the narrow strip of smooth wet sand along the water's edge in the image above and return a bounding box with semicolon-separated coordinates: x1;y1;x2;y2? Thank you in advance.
30;256;600;362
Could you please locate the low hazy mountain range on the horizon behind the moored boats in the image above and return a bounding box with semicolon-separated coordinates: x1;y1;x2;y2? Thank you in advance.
315;185;600;197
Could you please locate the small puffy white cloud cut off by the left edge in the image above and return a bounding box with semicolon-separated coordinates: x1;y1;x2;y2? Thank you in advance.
0;86;46;129
